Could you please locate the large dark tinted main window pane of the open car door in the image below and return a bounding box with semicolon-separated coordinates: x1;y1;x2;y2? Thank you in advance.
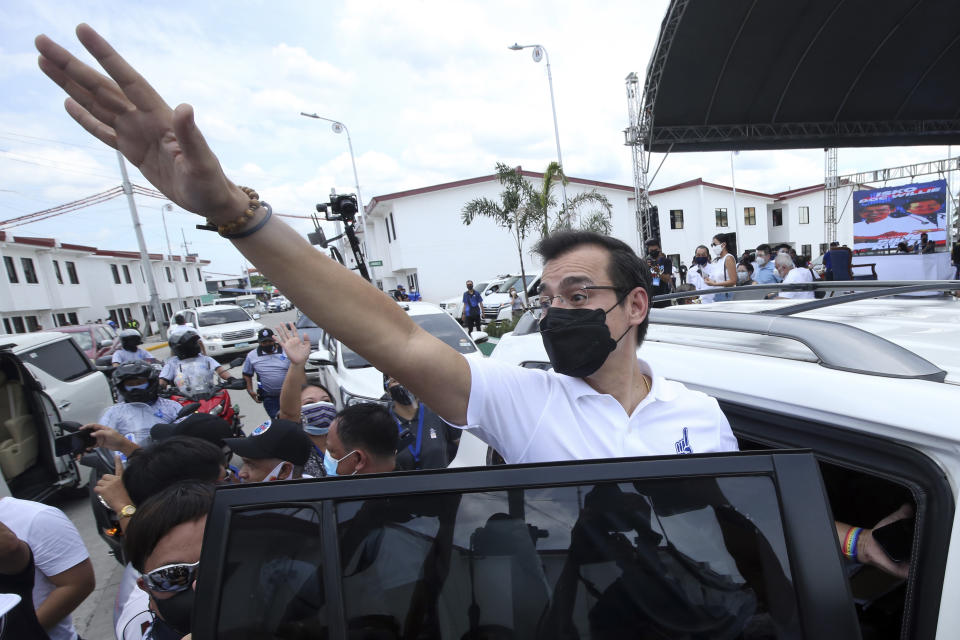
337;476;802;640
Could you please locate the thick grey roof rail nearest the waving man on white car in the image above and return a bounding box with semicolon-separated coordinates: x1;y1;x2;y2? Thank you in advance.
650;308;947;382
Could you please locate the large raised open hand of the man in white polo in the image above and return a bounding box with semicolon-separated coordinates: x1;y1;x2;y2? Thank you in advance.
35;24;249;222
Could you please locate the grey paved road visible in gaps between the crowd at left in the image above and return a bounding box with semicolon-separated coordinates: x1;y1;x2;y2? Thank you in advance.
62;311;296;640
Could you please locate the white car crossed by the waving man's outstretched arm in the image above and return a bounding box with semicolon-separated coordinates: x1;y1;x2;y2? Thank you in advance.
308;302;487;409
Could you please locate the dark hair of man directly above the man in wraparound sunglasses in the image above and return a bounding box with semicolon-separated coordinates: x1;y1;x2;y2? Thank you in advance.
123;436;224;508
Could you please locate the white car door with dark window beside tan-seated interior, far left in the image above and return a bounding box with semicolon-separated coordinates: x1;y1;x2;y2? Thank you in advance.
16;338;113;424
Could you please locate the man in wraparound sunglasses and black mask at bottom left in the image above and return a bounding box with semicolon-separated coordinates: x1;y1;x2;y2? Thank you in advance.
124;481;213;640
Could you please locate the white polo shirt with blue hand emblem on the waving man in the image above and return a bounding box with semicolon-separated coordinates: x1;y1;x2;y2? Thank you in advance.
454;359;738;464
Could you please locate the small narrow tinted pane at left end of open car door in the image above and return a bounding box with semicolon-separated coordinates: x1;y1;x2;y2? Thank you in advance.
216;507;327;640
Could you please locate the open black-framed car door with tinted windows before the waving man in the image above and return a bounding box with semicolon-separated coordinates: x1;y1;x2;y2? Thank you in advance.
199;451;860;639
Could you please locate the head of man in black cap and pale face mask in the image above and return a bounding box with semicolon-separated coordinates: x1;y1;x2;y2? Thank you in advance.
223;419;313;482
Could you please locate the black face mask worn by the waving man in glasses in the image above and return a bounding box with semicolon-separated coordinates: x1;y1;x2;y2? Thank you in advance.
540;296;632;378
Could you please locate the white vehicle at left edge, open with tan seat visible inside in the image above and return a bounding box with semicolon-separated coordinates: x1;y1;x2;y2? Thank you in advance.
0;332;113;500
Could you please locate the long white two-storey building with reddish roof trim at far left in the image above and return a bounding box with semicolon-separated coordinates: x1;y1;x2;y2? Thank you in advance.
0;231;210;333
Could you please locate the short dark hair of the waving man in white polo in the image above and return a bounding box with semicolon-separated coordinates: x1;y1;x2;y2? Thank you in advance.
533;231;651;345
